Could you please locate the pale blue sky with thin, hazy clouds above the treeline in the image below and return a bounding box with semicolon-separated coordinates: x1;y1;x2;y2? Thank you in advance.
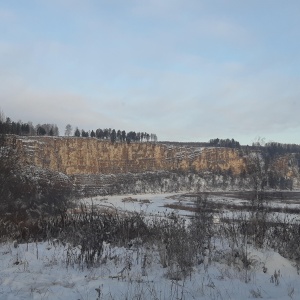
0;0;300;145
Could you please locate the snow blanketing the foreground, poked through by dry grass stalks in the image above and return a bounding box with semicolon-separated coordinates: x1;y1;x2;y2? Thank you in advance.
0;238;300;300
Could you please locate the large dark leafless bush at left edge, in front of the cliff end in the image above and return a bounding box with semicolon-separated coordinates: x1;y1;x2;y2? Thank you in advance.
0;135;73;236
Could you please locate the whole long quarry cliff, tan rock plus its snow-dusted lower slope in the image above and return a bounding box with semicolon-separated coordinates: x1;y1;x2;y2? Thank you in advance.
5;136;299;195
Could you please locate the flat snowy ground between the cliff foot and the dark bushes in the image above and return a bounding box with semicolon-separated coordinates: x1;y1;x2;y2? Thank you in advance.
79;193;300;222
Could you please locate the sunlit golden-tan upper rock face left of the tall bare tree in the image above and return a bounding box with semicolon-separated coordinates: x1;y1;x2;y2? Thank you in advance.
16;137;245;175
